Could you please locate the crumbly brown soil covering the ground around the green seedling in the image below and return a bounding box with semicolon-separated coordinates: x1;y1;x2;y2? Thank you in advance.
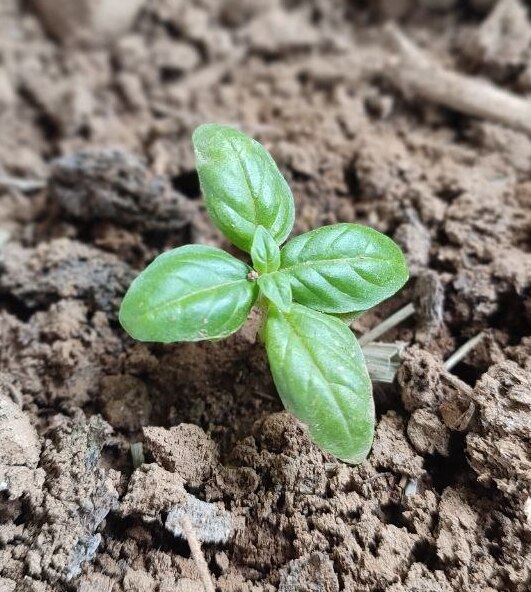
0;0;531;592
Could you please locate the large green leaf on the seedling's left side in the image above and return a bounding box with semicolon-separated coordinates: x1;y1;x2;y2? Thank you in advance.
120;245;258;343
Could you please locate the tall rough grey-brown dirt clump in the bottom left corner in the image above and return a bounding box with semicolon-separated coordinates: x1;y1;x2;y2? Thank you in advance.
2;417;119;589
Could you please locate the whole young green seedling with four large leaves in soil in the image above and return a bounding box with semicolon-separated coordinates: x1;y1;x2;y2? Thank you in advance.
120;124;408;463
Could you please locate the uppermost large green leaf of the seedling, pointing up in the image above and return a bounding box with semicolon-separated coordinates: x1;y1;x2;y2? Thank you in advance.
192;123;295;253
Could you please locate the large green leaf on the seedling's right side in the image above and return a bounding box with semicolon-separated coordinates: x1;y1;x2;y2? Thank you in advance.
276;224;408;313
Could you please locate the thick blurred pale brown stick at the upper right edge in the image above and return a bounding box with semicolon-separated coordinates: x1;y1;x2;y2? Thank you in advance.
385;23;531;134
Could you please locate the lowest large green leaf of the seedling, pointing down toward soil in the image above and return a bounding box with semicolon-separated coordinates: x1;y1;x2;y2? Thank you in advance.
263;303;374;464
